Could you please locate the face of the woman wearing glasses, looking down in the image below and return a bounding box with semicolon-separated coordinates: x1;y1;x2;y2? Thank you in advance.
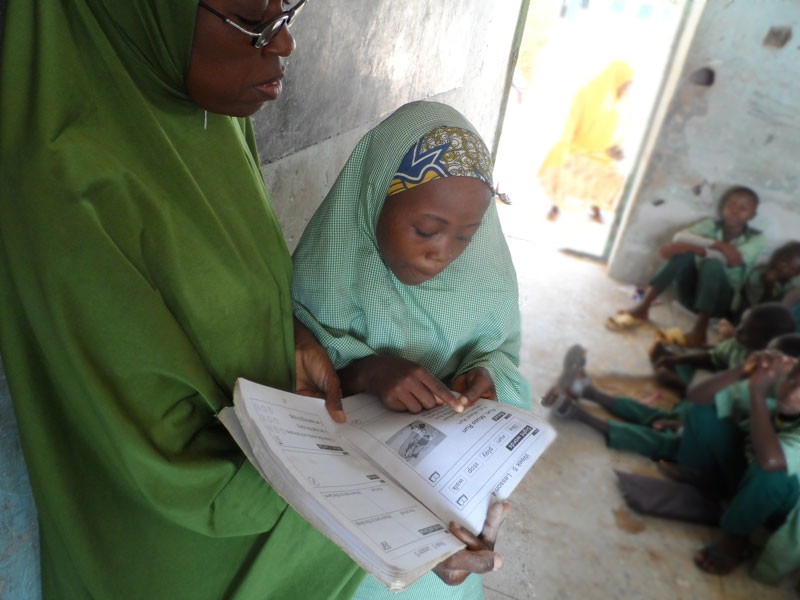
186;0;297;117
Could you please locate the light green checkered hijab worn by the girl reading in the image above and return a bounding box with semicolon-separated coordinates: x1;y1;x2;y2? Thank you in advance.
292;102;530;407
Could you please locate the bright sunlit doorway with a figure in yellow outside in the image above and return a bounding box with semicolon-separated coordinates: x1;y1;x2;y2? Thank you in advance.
495;0;686;258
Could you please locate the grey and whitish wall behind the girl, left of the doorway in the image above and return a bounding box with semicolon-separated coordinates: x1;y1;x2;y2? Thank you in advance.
254;0;526;249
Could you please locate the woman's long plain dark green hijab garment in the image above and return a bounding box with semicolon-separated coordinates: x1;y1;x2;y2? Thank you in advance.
0;0;361;600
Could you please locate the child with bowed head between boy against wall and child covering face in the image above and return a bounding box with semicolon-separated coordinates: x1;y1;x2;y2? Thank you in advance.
650;302;796;397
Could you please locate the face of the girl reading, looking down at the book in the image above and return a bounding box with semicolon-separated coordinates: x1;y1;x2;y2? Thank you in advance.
375;177;492;285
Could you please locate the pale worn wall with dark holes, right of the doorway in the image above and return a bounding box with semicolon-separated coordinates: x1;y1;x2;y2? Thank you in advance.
609;0;800;283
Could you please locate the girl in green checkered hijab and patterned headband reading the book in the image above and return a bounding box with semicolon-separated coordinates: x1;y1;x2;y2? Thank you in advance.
292;102;530;599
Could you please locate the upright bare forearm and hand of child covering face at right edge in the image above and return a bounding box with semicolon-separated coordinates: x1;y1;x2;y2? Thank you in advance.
749;352;795;471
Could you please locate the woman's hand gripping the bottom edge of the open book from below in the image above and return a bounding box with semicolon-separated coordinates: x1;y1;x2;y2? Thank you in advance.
433;501;511;585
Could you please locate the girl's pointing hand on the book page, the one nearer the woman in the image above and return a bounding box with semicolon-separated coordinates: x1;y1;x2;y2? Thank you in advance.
340;356;464;413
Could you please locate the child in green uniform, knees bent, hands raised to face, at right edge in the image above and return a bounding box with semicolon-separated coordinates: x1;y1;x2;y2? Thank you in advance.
675;350;800;575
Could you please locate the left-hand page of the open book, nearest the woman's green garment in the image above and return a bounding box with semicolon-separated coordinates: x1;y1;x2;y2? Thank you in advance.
228;379;464;589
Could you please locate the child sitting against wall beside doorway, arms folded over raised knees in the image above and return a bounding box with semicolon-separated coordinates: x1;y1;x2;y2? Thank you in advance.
606;186;765;347
